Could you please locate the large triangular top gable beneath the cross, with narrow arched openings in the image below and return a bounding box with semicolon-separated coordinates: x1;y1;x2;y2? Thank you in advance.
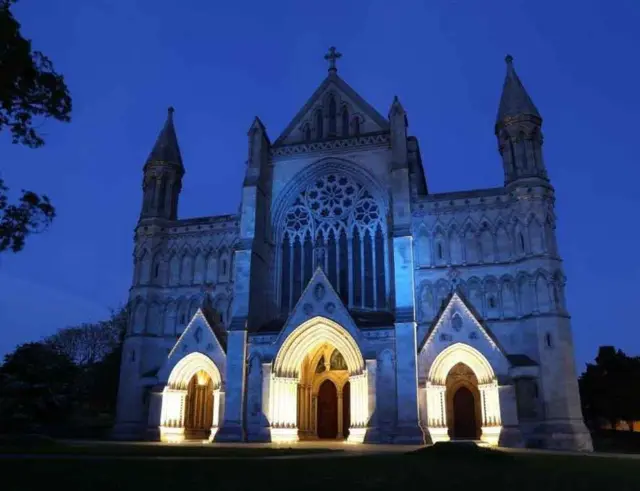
274;73;389;145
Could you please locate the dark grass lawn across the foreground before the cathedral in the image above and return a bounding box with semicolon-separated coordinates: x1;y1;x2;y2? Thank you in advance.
0;447;640;491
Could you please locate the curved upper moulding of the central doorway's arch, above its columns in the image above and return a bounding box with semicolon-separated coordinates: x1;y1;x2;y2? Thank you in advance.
273;316;365;378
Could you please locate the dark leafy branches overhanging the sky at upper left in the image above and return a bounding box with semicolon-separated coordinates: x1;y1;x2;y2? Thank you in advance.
0;0;71;253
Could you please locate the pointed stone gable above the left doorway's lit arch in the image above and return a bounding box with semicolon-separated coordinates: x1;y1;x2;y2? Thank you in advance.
158;307;227;382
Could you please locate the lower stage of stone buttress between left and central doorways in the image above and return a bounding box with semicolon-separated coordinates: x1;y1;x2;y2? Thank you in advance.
215;330;247;442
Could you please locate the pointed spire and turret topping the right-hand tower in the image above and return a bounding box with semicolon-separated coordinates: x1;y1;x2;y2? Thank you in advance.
495;55;548;185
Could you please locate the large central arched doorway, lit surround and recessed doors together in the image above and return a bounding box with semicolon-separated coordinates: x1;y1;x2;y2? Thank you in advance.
269;318;369;442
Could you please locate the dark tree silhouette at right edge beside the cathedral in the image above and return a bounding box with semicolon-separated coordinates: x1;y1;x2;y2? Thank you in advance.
579;346;640;427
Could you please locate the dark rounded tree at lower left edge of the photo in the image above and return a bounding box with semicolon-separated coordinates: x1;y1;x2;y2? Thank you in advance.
0;343;78;432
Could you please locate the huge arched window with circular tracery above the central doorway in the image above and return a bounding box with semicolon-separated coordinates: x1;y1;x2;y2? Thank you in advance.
278;173;388;314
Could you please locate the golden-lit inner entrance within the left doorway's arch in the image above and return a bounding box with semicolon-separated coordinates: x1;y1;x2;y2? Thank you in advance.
184;371;213;440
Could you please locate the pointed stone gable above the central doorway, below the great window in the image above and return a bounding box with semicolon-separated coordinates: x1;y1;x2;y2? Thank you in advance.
276;268;361;345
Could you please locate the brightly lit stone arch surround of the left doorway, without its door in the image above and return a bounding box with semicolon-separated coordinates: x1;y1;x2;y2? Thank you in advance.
160;352;224;442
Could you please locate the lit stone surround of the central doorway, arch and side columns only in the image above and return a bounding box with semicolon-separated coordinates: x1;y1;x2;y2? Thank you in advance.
269;316;370;442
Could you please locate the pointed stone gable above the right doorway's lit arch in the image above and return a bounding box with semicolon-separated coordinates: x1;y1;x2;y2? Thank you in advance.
418;291;510;374
